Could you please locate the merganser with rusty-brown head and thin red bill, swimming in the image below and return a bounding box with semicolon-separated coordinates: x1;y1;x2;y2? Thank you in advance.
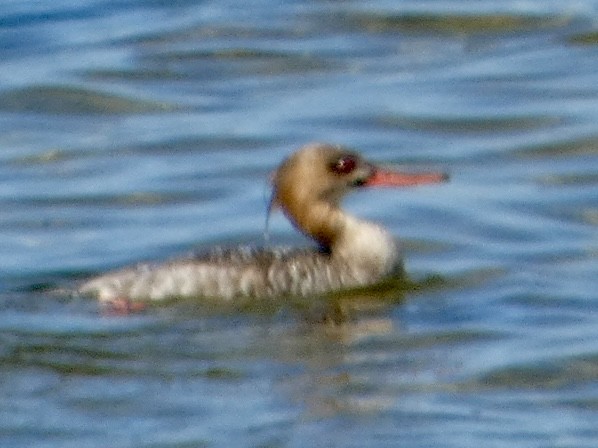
79;143;446;303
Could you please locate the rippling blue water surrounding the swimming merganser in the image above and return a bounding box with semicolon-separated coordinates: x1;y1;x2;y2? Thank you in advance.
0;0;598;447
